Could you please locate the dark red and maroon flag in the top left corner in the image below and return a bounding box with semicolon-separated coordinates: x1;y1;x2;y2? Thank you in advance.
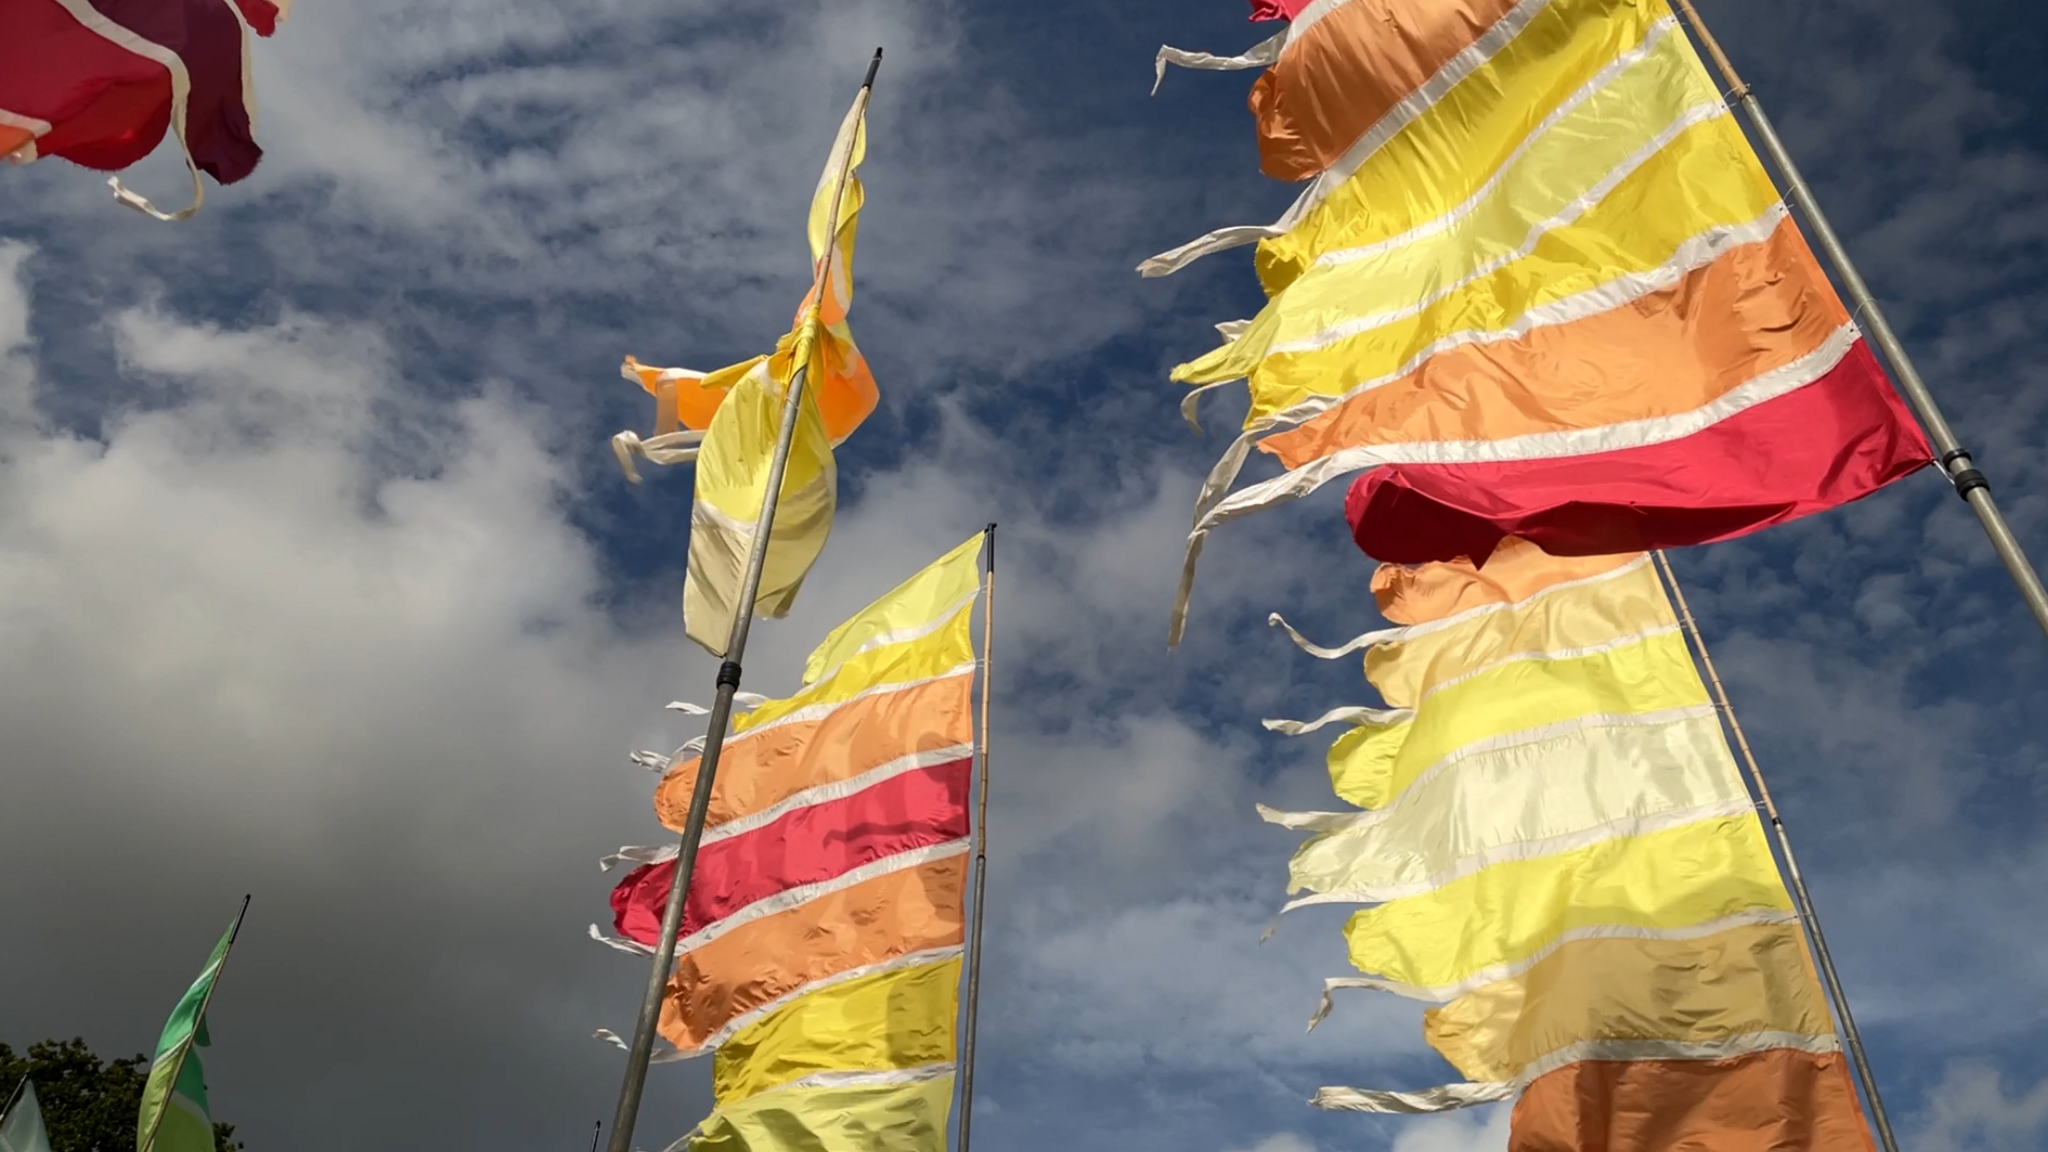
0;0;291;219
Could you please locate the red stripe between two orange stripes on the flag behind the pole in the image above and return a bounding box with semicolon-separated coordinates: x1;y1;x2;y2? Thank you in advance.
612;758;973;945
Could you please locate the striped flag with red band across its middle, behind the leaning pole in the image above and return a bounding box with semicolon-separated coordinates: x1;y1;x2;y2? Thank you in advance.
593;535;981;1152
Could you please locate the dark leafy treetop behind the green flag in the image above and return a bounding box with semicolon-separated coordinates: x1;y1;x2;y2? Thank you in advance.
0;1039;242;1152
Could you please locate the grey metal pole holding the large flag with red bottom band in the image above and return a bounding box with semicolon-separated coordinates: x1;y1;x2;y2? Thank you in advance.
1673;0;2048;633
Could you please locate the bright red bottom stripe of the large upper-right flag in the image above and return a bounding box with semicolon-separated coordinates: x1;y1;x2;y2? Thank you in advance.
1343;340;1933;564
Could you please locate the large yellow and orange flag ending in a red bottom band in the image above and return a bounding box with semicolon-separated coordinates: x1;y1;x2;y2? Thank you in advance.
1147;0;1933;625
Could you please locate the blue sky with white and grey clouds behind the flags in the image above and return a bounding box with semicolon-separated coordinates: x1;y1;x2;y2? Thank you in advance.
0;0;2048;1152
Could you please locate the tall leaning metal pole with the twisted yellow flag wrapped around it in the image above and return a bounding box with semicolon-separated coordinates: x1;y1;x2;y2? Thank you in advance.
606;49;883;1152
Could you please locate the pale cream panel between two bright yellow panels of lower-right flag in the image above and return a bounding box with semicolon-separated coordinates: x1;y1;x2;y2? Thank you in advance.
1266;707;1749;904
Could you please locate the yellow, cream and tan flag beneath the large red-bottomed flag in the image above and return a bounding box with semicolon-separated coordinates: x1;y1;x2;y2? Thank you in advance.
1262;539;1870;1152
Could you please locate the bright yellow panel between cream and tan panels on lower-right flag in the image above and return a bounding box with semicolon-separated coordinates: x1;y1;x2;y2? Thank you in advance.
1346;814;1792;988
